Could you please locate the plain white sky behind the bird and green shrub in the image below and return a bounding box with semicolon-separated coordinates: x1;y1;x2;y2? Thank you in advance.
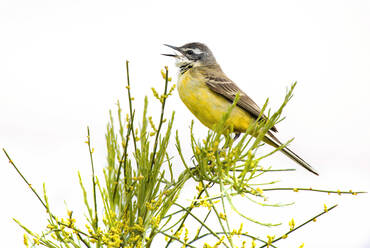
0;0;370;248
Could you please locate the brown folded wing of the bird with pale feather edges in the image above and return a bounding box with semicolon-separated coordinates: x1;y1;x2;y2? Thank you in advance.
201;66;277;132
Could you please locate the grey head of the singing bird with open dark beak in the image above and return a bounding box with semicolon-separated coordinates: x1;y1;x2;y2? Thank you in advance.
162;42;217;68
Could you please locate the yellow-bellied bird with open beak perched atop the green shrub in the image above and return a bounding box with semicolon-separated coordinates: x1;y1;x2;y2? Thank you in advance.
162;42;319;175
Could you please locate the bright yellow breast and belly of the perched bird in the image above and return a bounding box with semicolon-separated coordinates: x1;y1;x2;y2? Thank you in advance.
177;69;254;132
